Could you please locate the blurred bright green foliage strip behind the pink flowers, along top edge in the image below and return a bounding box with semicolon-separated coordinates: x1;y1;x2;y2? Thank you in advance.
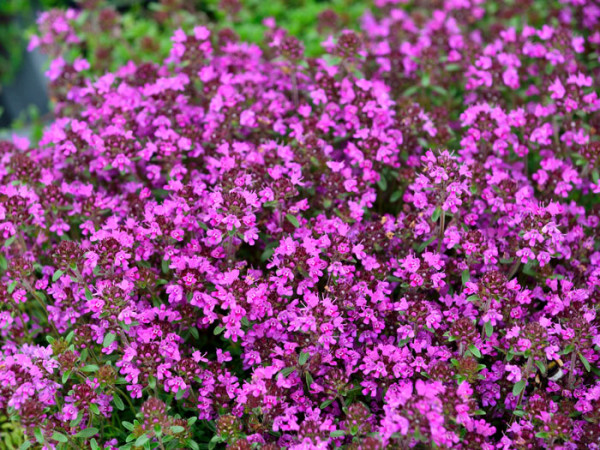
38;0;369;73
